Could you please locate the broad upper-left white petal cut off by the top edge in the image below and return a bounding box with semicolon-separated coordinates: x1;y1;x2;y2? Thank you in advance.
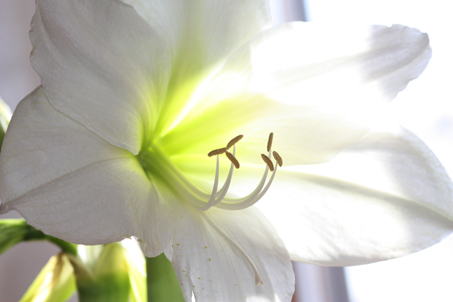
30;0;171;154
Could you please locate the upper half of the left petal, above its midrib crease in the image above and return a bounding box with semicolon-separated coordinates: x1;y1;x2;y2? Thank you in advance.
0;87;121;203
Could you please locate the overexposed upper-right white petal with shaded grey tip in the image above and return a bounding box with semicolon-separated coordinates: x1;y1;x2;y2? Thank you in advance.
164;23;431;165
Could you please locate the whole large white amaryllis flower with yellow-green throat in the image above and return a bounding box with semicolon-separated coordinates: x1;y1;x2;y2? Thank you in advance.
0;0;453;301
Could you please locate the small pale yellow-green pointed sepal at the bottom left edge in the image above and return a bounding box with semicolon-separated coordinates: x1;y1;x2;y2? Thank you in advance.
20;253;76;302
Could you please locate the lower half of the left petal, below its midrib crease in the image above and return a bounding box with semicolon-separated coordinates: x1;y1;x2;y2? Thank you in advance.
14;158;154;244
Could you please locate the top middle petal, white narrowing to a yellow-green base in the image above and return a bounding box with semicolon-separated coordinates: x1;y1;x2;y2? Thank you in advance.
118;0;271;132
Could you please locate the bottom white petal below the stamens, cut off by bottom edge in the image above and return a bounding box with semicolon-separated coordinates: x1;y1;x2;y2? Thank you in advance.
140;180;294;301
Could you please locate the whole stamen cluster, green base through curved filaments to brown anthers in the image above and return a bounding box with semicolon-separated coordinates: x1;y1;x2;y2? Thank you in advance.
138;133;283;211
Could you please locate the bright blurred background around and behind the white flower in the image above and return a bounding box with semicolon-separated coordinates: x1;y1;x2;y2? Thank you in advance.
0;0;453;302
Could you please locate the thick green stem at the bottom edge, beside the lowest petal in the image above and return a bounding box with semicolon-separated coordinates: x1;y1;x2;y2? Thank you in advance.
146;254;184;302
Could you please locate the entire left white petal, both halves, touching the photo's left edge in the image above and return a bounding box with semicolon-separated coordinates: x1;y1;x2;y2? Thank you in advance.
0;88;157;244
